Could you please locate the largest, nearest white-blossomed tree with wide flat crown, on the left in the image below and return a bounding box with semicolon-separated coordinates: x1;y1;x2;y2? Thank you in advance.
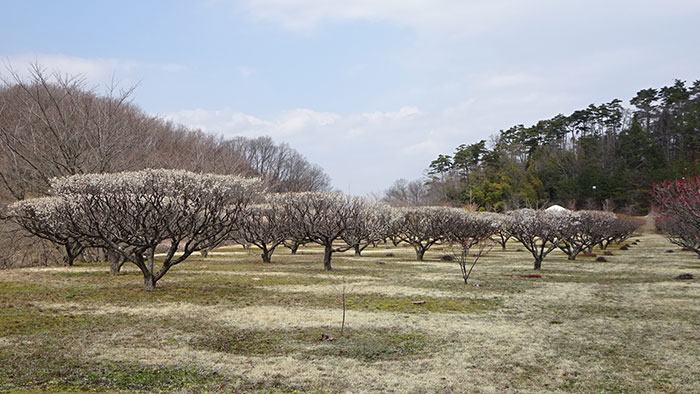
11;169;262;289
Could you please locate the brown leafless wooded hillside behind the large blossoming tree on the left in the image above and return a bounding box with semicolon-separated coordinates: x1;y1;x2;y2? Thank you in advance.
0;65;330;266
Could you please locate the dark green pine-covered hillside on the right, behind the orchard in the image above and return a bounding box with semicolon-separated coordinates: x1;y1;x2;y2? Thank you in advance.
385;80;700;214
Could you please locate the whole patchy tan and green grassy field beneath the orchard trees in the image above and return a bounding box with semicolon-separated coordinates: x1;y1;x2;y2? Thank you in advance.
0;234;700;393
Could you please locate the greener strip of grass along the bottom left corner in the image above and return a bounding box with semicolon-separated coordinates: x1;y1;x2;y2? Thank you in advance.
0;344;319;393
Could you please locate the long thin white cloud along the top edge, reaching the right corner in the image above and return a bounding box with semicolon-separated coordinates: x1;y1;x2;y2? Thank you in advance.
247;0;700;33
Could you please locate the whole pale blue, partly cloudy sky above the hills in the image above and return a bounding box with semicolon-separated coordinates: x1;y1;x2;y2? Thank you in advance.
0;0;700;195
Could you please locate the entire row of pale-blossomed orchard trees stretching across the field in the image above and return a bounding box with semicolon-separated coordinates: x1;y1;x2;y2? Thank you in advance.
8;169;635;289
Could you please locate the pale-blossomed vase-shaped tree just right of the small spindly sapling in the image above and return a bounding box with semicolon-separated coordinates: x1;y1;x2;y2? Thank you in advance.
508;208;579;270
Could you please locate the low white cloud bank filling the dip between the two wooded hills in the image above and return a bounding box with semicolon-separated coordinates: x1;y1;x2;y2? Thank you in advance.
165;106;474;193
